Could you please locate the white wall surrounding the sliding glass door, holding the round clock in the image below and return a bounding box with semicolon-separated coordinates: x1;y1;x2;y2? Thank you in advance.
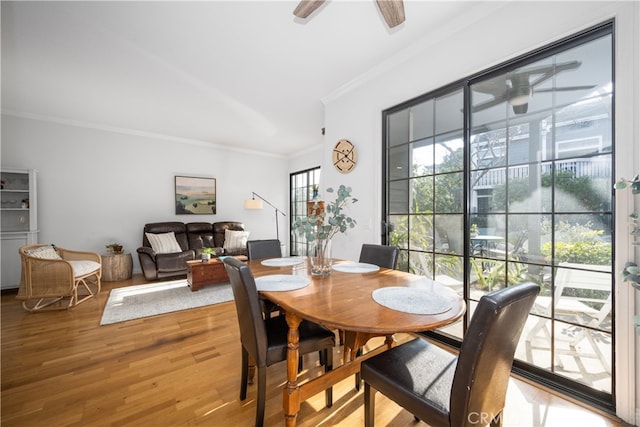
323;2;640;424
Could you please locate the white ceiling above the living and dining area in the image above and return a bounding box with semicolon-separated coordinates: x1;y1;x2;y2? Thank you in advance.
1;0;479;156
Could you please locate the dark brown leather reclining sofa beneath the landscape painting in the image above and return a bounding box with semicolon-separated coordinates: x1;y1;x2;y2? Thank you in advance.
138;221;247;280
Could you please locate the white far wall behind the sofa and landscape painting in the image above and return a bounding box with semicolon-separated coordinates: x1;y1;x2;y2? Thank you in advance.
1;115;288;272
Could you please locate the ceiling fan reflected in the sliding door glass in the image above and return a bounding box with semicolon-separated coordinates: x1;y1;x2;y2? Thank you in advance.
471;61;595;114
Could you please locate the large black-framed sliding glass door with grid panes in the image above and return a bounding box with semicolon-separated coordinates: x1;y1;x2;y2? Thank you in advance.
383;24;615;409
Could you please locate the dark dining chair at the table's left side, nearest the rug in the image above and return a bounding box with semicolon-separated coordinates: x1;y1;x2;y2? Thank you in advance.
224;258;335;426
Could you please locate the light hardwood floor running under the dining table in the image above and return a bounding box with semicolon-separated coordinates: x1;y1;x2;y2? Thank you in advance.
0;275;627;427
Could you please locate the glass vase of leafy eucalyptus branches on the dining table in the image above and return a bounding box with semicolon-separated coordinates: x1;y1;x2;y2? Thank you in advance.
292;185;358;276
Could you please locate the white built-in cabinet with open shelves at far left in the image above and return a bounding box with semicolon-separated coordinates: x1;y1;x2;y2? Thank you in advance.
0;168;38;289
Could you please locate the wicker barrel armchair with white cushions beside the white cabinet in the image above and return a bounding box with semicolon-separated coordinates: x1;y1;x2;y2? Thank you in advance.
16;245;102;312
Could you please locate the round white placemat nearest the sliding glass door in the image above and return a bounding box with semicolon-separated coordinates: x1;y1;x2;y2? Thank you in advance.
371;286;453;314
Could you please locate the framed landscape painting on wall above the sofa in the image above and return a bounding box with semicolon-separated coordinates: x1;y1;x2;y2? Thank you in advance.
175;176;216;215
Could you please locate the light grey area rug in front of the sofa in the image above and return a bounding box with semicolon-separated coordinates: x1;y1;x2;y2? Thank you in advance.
100;280;233;325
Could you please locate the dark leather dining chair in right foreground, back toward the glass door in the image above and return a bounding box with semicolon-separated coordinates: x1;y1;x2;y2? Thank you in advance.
361;283;540;427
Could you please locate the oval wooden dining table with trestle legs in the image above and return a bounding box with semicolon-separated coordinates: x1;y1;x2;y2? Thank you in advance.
247;258;466;426
